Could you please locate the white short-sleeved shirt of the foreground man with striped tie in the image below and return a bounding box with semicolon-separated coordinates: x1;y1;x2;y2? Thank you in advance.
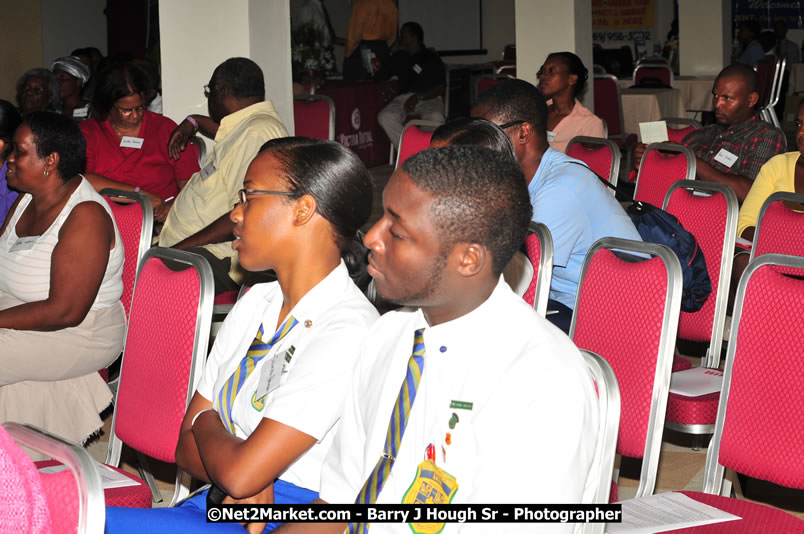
320;280;598;533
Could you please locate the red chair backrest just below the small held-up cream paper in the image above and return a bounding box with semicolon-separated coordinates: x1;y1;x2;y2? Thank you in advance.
634;143;695;207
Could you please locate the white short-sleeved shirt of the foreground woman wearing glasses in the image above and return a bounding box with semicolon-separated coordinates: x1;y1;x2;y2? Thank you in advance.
198;262;378;491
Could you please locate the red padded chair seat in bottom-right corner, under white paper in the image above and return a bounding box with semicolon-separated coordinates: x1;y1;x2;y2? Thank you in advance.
667;491;804;534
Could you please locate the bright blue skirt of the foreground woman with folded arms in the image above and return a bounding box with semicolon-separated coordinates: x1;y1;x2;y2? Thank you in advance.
106;480;318;534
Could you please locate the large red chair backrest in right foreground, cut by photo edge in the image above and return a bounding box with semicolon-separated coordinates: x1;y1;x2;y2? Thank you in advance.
704;254;804;494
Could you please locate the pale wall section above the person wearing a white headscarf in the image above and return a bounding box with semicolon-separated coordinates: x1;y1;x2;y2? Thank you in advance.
40;0;106;67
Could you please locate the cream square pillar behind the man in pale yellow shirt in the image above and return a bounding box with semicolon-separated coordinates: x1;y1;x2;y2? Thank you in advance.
159;0;293;132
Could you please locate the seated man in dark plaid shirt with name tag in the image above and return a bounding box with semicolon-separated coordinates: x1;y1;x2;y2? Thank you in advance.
633;65;786;202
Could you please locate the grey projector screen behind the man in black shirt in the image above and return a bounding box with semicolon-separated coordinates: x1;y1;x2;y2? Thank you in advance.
399;0;486;55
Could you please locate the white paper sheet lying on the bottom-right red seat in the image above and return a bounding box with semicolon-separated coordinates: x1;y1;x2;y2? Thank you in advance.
606;492;740;534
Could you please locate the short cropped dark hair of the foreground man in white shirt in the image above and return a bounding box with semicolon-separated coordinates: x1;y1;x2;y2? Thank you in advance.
402;145;533;276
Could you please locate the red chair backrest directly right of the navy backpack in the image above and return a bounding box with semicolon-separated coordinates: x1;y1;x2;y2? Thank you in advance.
662;180;739;367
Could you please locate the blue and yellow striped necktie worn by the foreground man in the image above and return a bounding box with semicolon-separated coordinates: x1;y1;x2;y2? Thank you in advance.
349;328;424;534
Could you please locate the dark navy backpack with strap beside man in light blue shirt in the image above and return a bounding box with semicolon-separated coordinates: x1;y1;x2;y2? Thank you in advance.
573;162;712;312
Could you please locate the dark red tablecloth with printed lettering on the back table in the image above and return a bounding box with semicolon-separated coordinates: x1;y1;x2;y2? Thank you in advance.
317;81;391;168
